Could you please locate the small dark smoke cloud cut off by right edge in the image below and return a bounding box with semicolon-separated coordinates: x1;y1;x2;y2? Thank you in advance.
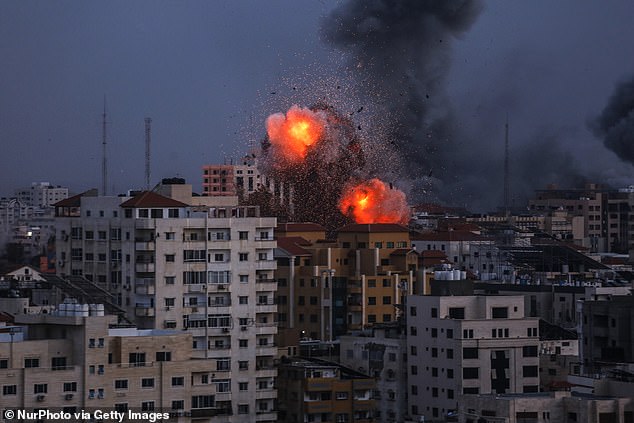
591;77;634;164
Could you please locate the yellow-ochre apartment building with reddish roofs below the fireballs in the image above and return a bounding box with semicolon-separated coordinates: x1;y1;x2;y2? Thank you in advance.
275;224;422;354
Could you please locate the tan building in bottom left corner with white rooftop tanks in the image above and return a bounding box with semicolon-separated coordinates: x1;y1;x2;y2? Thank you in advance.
0;312;275;422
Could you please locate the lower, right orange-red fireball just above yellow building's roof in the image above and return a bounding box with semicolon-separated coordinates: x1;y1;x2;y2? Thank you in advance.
339;178;410;224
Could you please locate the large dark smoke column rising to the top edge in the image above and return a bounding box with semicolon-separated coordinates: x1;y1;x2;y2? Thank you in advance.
322;0;482;177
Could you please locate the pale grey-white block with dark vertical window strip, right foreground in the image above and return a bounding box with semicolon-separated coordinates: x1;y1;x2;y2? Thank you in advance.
407;296;539;419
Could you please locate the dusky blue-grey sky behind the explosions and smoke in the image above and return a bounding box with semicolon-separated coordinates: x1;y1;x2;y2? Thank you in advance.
0;0;634;208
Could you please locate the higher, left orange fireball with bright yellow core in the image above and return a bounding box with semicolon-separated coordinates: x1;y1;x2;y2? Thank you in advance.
266;105;326;162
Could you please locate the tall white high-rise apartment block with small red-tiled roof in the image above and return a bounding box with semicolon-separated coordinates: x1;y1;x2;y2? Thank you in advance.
56;185;277;421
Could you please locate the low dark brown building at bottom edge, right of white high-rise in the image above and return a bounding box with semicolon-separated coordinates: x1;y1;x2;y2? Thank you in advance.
278;359;376;423
